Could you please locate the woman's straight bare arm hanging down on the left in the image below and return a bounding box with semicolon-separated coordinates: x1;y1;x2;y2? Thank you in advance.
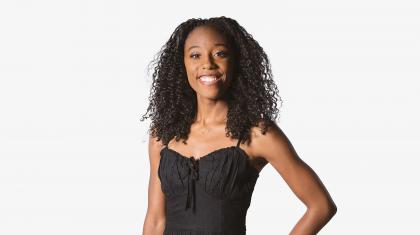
143;134;166;235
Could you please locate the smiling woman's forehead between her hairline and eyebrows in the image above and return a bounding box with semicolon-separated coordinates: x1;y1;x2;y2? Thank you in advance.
184;26;227;50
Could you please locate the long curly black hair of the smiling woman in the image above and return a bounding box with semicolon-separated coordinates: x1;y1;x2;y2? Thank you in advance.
141;16;283;145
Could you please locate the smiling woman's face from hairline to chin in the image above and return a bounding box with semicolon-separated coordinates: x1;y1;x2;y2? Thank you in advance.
184;26;233;99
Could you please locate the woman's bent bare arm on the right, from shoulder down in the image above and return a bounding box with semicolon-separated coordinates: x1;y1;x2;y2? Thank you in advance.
251;123;337;235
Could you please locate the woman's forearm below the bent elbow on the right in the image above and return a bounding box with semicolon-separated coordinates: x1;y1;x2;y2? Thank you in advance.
289;208;337;235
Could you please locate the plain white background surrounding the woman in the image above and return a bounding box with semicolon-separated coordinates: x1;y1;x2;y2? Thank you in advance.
0;0;420;235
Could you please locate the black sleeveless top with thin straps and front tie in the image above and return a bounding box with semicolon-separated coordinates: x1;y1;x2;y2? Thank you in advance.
158;136;259;235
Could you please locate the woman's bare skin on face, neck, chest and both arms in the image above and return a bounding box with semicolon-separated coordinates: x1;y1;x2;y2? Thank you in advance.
143;26;337;235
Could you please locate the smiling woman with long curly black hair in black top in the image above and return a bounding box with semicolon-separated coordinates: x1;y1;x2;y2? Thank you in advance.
142;17;337;235
